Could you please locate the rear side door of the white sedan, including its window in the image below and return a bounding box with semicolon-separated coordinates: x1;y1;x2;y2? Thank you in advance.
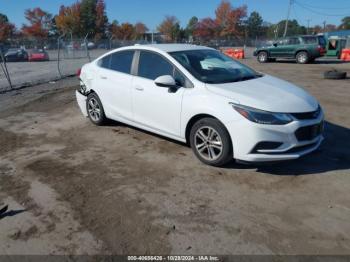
98;50;135;120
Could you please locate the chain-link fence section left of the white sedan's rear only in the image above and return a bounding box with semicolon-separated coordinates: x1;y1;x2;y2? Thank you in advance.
0;38;99;92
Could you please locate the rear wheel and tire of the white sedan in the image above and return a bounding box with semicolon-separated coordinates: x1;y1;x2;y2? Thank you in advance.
86;93;107;126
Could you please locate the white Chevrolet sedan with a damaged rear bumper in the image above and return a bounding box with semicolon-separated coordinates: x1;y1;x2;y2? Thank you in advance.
76;44;324;166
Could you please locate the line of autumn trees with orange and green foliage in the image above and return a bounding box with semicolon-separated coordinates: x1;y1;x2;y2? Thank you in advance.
0;0;350;42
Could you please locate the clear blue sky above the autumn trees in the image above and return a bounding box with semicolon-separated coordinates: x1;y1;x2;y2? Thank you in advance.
0;0;350;31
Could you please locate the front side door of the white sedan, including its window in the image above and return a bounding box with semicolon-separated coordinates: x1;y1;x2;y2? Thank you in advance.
132;51;185;136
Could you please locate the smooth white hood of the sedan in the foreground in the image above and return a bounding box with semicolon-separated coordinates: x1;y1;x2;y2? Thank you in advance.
206;75;318;113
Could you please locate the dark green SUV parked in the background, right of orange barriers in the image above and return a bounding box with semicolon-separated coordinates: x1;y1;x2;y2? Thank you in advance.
254;35;326;64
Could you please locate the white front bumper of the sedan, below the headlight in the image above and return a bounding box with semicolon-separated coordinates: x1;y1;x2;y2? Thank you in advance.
226;113;324;162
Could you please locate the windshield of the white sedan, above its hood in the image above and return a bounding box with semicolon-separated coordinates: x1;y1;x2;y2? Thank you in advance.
169;49;261;84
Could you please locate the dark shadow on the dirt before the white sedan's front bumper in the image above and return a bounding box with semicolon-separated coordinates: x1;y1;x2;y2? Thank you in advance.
227;121;350;176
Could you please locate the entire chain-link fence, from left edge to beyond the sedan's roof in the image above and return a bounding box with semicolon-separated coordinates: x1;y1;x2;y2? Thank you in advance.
0;37;261;93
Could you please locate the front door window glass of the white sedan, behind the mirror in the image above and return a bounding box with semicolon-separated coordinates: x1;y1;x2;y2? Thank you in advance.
138;51;174;80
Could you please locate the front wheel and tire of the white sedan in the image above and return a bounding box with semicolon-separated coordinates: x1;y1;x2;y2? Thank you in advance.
190;118;233;167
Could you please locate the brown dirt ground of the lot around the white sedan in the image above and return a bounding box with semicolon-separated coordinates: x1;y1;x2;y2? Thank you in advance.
0;59;350;255
